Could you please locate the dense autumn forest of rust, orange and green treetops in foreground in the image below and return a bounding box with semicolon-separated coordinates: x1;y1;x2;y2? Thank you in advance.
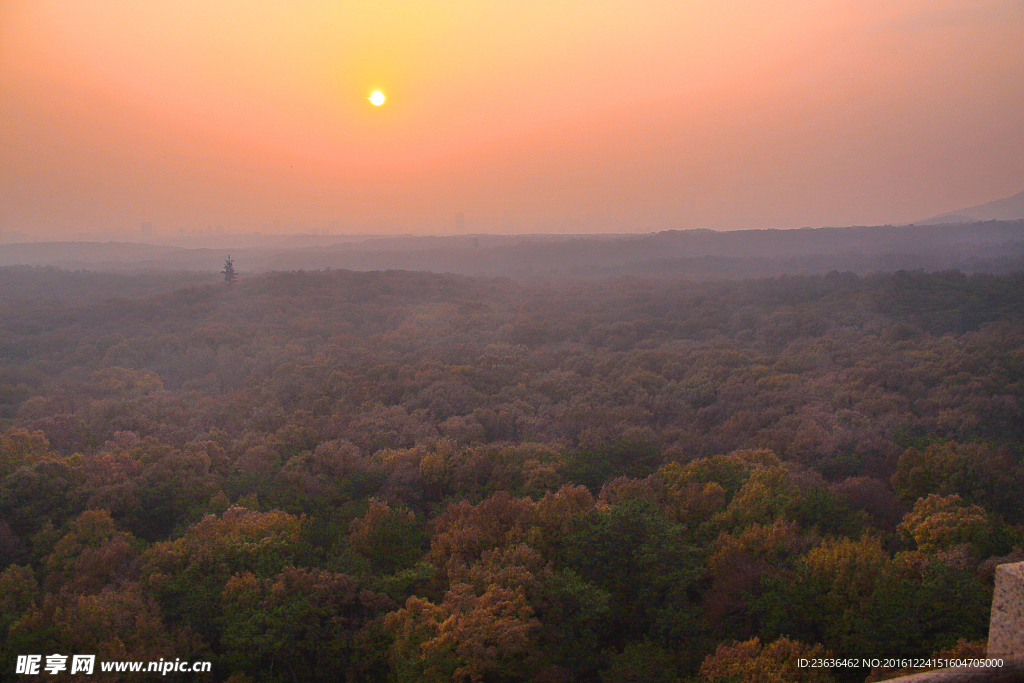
0;268;1024;683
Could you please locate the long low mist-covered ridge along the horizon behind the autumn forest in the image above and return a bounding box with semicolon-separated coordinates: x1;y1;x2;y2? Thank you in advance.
0;220;1024;280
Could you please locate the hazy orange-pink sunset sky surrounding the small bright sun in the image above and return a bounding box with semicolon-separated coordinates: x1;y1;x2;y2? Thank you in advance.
0;0;1024;236
